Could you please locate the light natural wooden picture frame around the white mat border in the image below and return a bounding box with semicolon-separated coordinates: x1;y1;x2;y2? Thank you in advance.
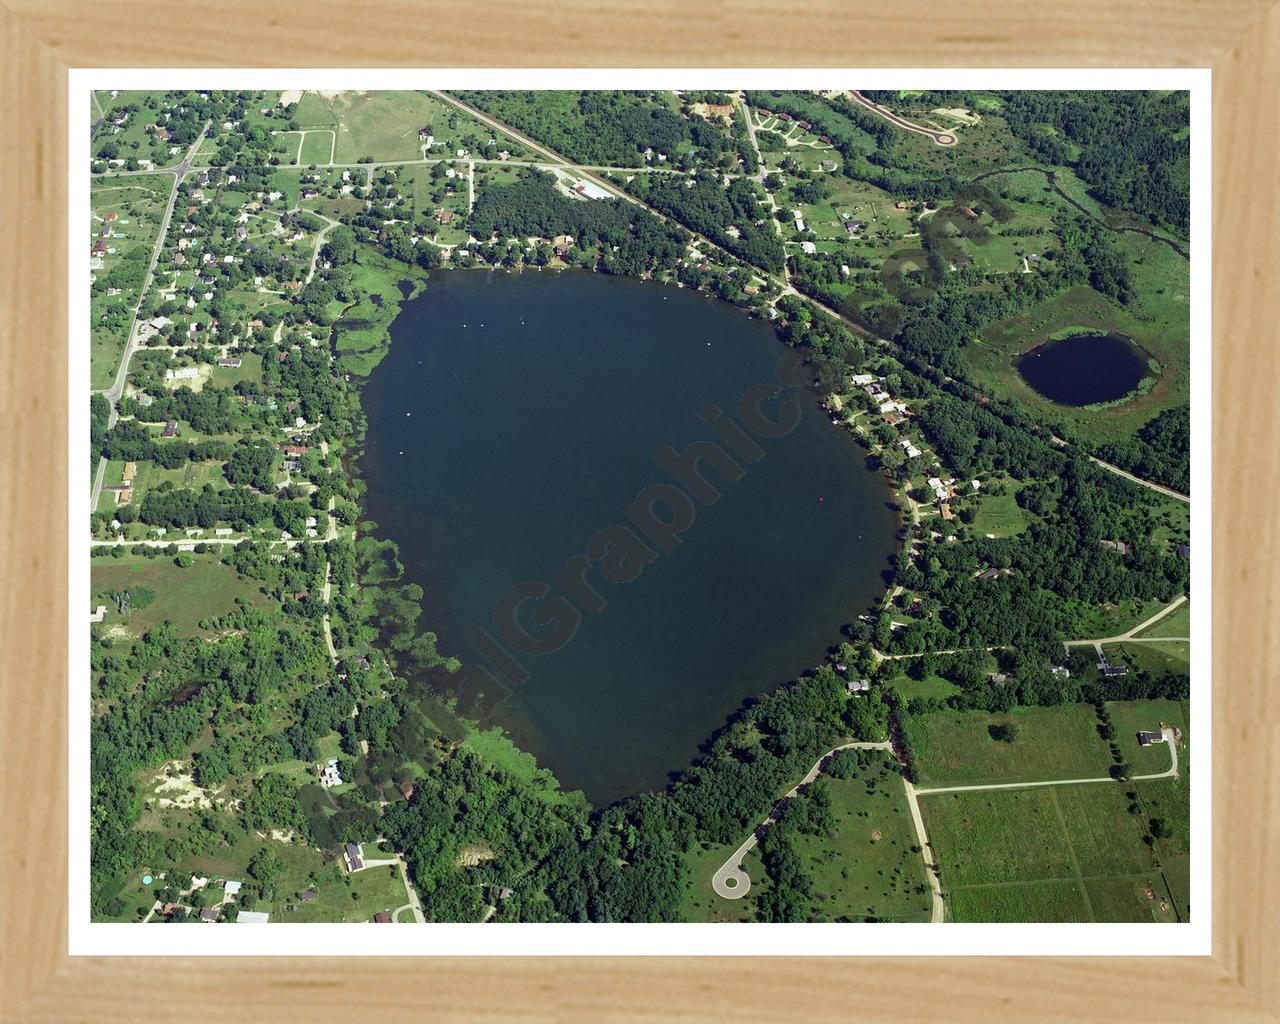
0;0;1280;1023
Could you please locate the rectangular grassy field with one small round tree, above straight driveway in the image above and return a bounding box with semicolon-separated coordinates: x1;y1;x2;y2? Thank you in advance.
913;704;1111;787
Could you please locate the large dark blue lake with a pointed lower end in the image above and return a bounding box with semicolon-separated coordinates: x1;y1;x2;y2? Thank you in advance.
358;271;899;804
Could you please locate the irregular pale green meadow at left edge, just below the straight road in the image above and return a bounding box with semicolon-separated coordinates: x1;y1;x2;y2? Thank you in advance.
90;554;268;635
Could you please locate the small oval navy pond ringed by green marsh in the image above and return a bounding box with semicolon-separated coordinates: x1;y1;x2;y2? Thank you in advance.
1015;334;1147;406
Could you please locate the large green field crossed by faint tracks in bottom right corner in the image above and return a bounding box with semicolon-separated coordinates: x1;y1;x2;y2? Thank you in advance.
920;783;1175;922
